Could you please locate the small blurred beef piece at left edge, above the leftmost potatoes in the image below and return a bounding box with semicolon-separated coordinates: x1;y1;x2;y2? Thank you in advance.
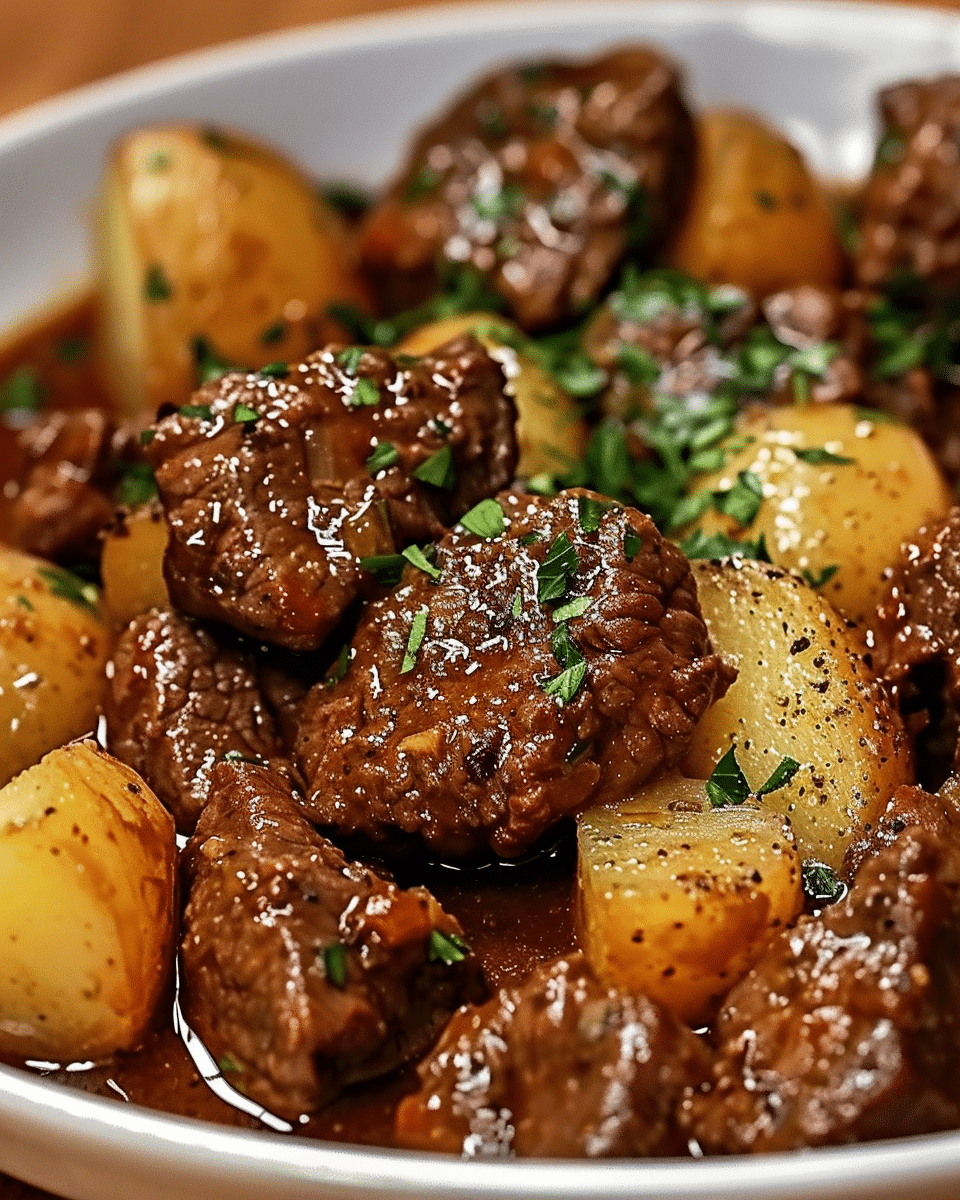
5;408;138;562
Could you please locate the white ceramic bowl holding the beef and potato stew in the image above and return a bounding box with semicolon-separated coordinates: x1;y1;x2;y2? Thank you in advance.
0;0;960;1200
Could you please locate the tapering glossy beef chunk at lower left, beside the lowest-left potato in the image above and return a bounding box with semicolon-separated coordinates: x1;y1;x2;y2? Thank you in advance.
181;761;484;1117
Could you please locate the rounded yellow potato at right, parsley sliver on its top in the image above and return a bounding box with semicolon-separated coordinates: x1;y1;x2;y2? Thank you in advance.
694;404;950;624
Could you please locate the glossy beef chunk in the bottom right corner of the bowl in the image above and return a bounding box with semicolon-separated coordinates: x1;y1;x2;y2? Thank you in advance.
682;829;960;1153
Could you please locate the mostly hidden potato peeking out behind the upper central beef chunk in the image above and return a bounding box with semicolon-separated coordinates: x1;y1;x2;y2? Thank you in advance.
397;312;587;479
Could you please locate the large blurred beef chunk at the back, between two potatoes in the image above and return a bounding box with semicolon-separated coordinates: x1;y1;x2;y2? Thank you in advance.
361;47;695;330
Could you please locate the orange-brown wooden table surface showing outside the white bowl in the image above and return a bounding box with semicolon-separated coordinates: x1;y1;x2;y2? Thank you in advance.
0;0;960;1200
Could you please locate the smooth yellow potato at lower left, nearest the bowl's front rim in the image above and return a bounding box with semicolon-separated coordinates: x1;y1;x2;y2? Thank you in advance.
0;742;176;1062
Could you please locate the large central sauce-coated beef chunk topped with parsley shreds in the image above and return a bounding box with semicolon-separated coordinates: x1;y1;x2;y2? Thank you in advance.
298;491;732;857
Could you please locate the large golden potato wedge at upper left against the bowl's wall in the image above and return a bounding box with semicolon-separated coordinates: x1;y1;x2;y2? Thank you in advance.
98;127;367;415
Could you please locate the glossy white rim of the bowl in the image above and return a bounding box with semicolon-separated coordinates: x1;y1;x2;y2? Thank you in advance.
0;0;960;1200
